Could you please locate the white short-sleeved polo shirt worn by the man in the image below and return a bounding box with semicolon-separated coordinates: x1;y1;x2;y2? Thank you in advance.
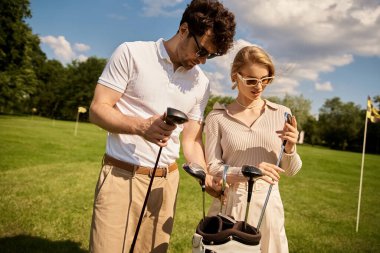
98;39;210;167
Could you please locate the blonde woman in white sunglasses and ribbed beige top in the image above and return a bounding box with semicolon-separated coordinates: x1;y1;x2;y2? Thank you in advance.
206;46;302;253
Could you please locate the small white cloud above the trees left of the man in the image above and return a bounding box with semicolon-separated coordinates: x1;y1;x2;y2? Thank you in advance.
40;35;90;64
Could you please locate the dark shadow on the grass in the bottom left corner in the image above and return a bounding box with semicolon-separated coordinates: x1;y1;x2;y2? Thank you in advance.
0;235;87;253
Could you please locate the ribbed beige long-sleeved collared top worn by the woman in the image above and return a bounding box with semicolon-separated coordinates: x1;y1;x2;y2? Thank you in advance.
206;100;302;182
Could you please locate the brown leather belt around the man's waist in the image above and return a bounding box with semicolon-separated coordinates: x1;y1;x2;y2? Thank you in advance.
103;154;178;177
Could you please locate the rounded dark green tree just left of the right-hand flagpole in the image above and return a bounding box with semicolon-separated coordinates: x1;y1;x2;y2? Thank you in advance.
318;97;364;150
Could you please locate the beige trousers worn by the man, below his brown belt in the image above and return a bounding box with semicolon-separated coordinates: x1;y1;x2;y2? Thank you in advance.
90;162;179;253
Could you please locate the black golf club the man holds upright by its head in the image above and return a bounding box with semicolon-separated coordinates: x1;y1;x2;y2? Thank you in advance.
129;107;188;253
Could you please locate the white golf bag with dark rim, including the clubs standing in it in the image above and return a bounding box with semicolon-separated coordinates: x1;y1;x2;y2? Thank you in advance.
182;163;262;253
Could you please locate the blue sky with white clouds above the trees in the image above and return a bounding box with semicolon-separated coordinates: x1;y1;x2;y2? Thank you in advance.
26;0;380;114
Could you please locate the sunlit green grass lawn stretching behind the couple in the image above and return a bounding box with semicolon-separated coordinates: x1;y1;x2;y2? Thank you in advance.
0;116;380;253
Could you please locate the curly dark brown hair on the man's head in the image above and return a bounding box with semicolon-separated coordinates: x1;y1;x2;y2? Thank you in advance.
180;0;236;55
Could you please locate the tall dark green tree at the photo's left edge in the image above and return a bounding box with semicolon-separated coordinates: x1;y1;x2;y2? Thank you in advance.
0;0;46;112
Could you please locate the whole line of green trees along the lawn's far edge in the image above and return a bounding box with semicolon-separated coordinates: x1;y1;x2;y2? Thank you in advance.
0;0;380;154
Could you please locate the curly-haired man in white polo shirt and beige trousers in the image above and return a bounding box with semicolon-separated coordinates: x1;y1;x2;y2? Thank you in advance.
90;0;236;253
